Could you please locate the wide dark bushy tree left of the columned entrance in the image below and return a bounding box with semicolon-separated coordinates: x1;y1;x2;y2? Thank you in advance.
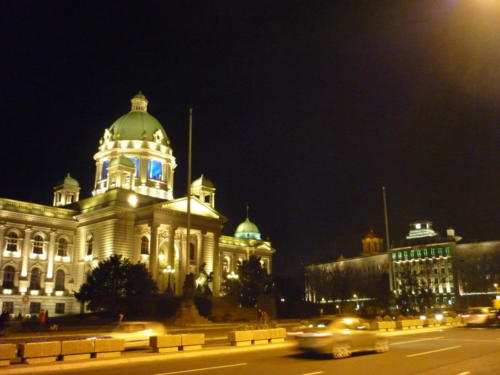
75;254;156;313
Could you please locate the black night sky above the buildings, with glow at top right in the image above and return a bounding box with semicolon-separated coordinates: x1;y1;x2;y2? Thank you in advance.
0;0;500;273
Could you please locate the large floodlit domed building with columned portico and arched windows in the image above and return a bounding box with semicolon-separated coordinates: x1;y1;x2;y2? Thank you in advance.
0;93;275;315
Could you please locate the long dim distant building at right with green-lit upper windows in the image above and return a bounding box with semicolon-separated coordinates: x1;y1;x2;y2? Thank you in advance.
306;220;500;307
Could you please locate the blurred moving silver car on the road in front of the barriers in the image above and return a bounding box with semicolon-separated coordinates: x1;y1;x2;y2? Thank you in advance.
296;316;389;358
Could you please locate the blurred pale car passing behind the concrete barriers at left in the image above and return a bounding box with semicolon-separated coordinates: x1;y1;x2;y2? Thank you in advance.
110;322;167;348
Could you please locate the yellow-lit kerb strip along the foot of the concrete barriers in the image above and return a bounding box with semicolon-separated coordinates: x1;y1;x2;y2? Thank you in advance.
0;326;456;375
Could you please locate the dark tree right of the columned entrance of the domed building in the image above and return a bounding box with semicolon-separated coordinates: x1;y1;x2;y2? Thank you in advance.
223;255;272;307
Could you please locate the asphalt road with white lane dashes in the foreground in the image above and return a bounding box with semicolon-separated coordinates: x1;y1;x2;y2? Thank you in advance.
58;328;500;375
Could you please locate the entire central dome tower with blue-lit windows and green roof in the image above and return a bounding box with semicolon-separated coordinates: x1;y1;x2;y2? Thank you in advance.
92;92;177;199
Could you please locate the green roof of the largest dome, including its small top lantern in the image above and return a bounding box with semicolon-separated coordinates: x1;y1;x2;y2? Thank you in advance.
109;92;170;145
